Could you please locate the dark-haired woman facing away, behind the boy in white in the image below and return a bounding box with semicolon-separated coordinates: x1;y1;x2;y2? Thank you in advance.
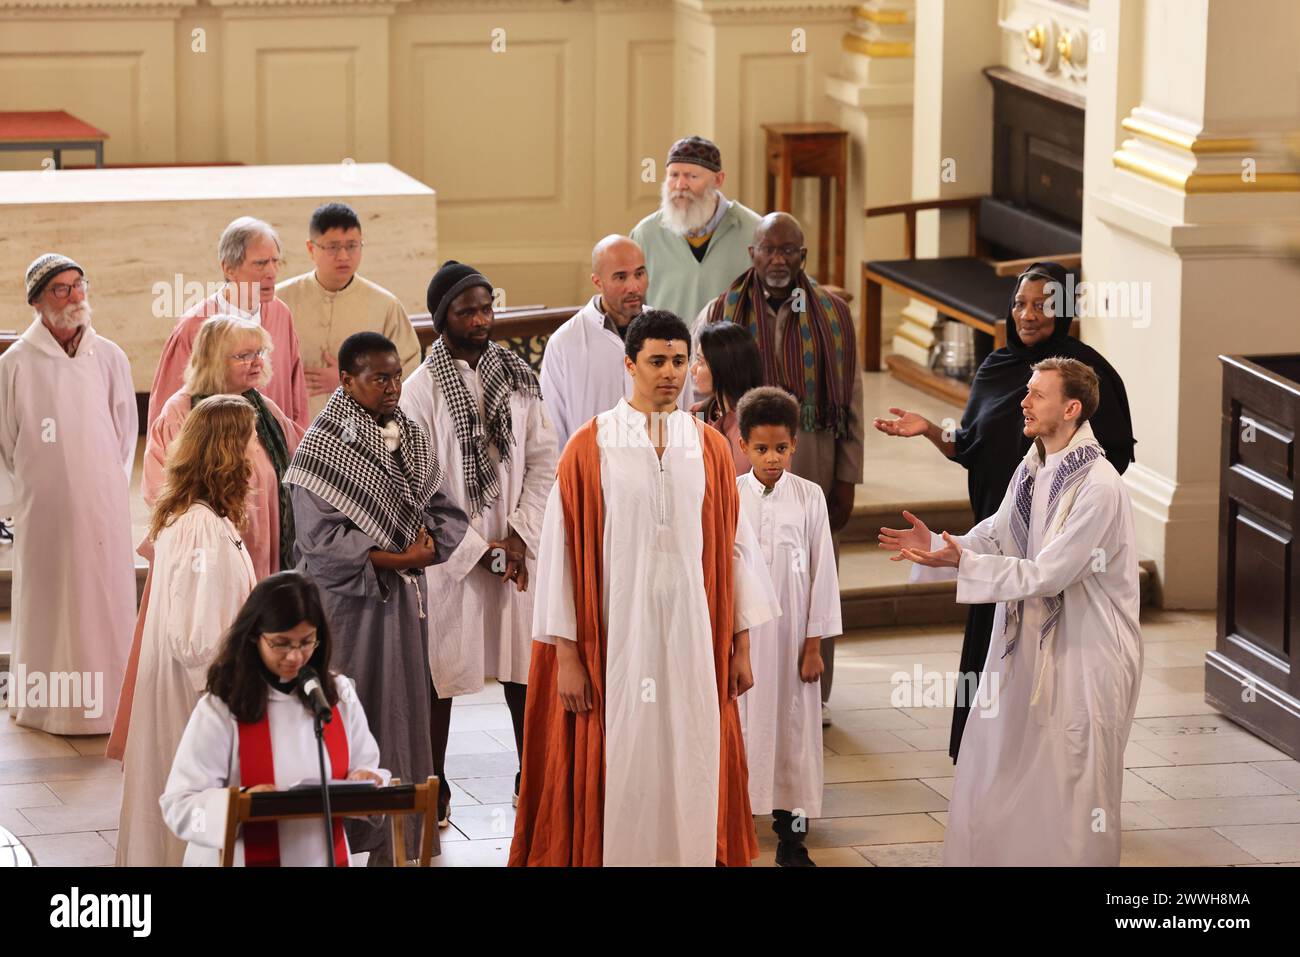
690;322;763;475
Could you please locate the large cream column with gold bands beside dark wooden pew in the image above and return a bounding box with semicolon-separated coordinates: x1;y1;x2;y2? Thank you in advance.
1083;0;1300;607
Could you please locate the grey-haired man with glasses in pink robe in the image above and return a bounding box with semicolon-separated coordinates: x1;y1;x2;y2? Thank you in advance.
148;216;312;429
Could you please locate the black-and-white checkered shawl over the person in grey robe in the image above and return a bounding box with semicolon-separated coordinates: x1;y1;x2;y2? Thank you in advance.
283;387;442;551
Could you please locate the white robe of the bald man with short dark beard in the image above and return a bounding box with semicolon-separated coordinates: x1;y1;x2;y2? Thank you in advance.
541;295;692;450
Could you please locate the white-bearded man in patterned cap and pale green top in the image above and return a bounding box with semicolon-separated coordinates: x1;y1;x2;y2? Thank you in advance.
632;137;759;322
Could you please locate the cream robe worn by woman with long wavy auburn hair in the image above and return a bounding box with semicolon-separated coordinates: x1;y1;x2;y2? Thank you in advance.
117;503;257;867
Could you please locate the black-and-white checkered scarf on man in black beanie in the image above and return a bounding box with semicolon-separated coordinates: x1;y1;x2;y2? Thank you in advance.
425;337;542;518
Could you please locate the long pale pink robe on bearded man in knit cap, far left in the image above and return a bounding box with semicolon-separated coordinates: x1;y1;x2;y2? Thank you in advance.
0;320;138;735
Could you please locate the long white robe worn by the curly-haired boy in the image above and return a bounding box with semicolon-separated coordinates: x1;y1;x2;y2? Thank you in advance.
736;472;844;818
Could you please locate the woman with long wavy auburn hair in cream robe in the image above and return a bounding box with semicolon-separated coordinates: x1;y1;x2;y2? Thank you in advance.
117;395;257;866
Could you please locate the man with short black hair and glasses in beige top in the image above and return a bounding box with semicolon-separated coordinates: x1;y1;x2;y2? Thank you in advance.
276;203;420;419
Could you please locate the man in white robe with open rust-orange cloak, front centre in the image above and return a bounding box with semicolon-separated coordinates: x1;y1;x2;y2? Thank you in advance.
510;311;779;866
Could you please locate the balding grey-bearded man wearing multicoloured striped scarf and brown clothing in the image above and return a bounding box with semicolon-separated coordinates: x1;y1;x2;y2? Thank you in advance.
696;212;865;724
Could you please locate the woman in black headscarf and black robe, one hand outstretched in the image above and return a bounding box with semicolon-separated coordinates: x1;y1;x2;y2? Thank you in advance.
875;263;1134;762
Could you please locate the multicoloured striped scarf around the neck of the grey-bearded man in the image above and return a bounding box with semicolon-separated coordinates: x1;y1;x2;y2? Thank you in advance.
709;267;857;438
